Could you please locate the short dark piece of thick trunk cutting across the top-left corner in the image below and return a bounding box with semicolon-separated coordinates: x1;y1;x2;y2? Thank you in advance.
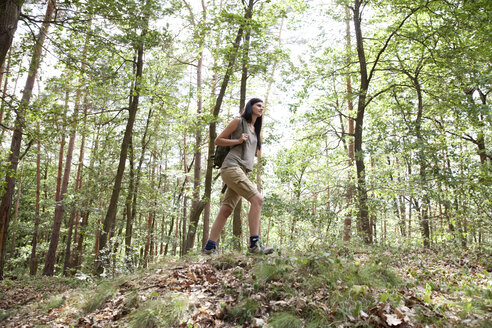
0;0;24;66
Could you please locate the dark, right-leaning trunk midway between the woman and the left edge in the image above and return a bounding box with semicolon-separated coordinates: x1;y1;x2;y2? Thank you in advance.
95;29;147;274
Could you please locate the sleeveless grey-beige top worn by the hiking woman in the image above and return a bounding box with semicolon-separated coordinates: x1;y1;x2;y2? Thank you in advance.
221;117;256;172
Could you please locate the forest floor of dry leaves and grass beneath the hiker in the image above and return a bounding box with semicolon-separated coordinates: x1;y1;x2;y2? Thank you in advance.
0;247;492;328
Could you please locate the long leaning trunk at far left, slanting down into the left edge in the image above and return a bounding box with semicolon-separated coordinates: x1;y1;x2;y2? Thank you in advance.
0;0;55;280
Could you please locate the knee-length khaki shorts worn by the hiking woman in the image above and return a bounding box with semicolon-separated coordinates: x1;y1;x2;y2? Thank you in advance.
220;166;258;208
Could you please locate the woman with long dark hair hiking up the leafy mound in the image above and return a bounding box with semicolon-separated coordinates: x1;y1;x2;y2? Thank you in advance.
203;98;273;254
